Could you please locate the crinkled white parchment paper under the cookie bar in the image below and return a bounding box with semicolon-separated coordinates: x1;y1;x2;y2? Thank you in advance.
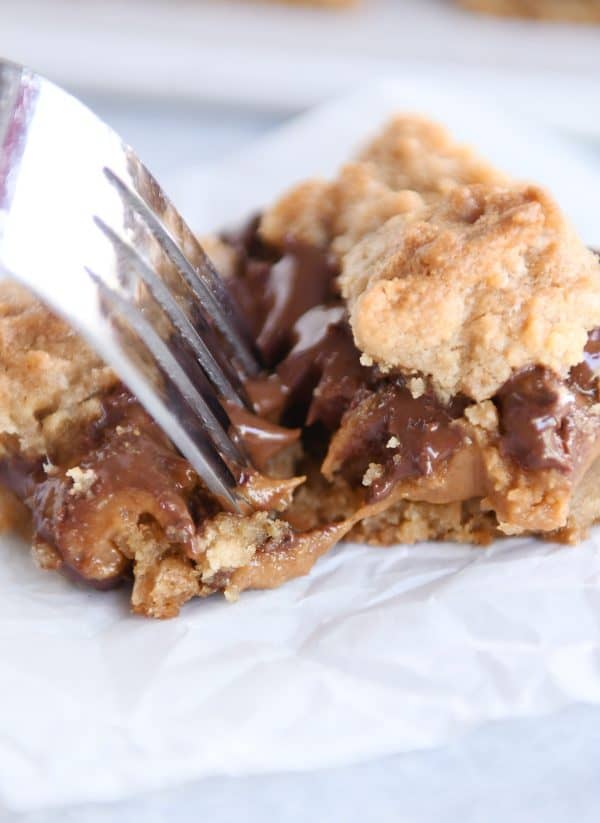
0;82;600;809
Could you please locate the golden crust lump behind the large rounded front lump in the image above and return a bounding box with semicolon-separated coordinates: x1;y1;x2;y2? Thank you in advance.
260;115;508;257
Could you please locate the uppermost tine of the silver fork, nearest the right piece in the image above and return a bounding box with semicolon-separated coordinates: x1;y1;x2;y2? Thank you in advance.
104;168;260;377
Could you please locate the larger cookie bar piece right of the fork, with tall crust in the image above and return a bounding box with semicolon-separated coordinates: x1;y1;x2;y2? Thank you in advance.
233;117;600;542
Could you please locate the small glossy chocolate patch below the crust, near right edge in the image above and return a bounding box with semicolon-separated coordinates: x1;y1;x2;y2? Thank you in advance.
496;366;575;471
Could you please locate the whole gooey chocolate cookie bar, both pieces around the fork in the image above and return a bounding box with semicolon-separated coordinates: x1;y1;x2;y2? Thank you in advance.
0;116;600;617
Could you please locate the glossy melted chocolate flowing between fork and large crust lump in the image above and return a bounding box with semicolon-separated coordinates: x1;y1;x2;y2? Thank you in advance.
227;216;465;497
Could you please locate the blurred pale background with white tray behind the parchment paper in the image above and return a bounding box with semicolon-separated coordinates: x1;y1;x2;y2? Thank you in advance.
0;0;600;183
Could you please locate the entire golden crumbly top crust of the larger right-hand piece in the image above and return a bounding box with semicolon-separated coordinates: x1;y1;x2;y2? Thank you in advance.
261;116;600;400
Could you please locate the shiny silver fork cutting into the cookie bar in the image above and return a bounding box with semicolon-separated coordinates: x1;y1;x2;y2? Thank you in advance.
0;60;260;512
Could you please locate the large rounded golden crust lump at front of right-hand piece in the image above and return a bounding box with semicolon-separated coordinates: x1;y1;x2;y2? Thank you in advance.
340;186;600;400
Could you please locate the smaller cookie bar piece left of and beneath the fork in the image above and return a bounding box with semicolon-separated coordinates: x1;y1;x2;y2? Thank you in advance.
0;281;349;617
